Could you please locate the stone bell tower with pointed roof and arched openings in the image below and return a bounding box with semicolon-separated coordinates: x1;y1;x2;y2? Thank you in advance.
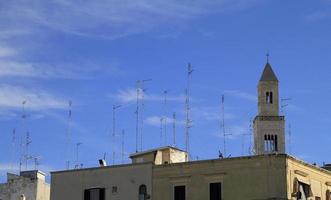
254;61;285;155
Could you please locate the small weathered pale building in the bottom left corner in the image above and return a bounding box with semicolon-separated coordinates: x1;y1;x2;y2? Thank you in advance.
0;170;50;200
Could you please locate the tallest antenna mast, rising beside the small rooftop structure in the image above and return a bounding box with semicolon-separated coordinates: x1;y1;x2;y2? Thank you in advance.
185;63;193;157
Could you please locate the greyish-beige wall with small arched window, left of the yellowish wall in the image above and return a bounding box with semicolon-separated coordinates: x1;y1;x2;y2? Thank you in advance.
51;164;152;200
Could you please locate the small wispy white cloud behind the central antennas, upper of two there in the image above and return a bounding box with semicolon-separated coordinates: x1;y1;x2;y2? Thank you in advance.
109;88;185;103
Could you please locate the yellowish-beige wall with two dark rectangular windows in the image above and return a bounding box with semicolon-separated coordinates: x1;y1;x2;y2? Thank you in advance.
153;155;287;200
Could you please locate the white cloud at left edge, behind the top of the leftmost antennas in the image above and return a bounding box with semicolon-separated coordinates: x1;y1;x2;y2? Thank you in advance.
0;84;67;110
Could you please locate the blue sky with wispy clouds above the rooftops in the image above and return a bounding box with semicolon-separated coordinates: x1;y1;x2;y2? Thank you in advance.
0;0;331;180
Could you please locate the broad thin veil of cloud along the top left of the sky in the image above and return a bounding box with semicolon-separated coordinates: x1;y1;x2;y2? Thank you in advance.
0;0;263;39
